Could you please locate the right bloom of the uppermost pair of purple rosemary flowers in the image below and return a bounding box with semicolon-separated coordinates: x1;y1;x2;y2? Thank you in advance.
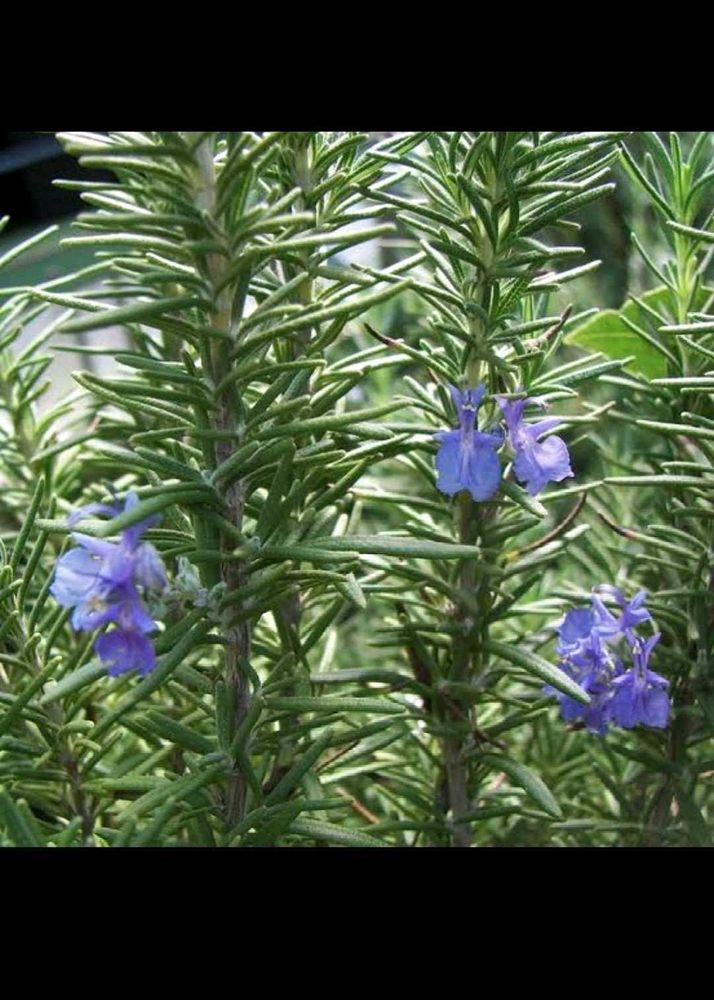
497;396;573;496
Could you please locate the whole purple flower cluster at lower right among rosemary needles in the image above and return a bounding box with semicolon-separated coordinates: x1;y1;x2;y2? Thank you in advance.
545;584;669;735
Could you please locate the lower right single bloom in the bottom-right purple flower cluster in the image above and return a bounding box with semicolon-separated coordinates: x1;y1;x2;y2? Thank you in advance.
611;632;669;729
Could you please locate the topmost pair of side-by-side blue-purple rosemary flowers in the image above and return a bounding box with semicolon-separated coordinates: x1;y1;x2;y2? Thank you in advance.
436;385;573;500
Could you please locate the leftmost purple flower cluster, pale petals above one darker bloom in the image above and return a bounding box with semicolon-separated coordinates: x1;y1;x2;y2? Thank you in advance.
50;493;167;676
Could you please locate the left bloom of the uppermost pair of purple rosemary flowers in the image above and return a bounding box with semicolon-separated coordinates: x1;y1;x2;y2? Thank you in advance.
436;385;503;500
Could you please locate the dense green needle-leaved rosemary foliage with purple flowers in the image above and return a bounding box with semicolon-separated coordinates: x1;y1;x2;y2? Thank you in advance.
0;132;714;847
